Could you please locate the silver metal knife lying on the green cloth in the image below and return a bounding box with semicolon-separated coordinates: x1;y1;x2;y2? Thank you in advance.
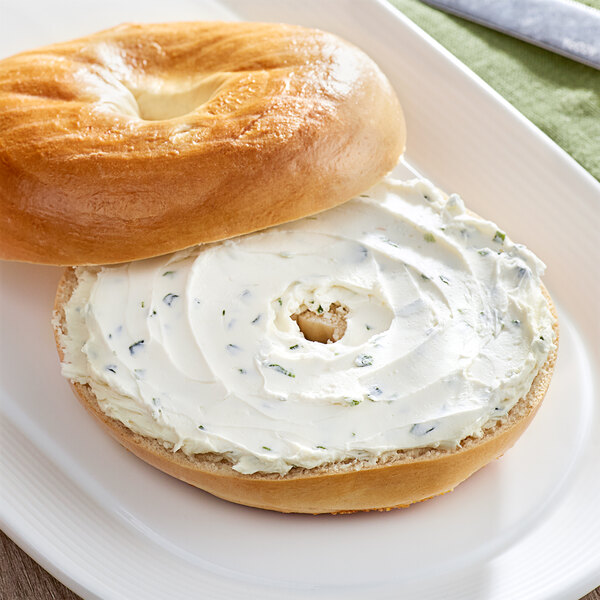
422;0;600;69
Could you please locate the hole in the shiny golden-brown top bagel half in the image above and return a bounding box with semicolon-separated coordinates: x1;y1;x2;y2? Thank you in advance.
130;77;223;121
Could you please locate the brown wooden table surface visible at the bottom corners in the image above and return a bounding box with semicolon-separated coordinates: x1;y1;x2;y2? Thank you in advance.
0;531;600;600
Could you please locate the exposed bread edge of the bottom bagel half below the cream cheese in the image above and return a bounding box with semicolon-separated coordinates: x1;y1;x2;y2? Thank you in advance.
55;269;558;514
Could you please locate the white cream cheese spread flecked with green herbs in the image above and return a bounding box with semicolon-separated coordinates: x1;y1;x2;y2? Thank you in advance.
58;178;554;474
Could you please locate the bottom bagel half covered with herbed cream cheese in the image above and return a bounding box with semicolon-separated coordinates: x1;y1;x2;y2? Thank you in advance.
54;180;558;514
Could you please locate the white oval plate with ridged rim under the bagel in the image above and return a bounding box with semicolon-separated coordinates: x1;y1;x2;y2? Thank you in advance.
0;0;600;600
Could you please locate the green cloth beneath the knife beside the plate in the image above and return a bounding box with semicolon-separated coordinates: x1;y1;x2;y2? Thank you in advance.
390;0;600;180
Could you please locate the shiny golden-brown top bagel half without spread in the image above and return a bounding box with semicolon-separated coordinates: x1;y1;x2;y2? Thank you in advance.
0;22;405;265
